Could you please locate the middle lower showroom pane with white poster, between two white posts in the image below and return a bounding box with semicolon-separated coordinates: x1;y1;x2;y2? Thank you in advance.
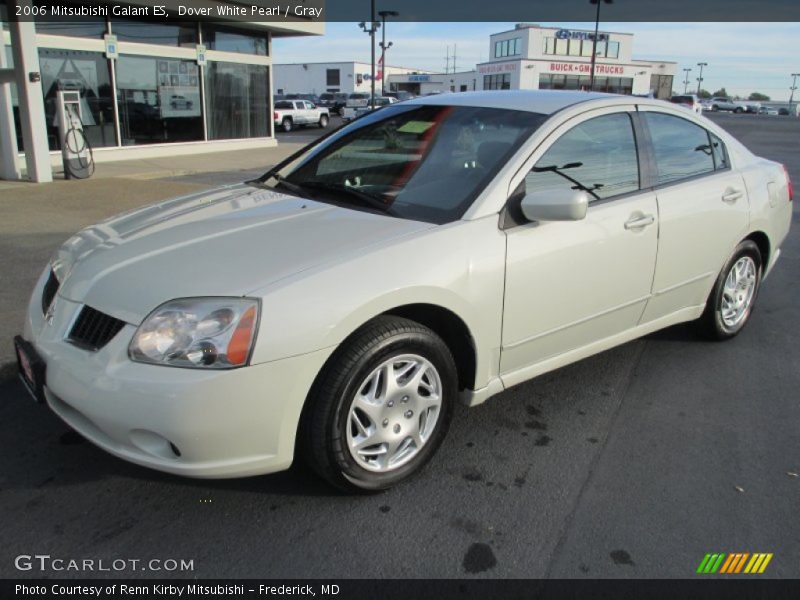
117;56;203;146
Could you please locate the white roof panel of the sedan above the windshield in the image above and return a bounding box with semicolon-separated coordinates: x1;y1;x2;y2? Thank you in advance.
404;90;620;114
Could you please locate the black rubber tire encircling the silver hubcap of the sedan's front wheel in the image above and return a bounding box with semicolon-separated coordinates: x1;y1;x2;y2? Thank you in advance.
326;331;458;491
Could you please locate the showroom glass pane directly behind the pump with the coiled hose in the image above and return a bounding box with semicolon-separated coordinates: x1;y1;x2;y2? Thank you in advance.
39;48;117;150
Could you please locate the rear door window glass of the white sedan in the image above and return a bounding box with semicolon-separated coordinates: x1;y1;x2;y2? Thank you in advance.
644;112;724;185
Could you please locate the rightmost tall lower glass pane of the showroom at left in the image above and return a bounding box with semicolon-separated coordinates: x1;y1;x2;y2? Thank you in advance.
205;61;270;140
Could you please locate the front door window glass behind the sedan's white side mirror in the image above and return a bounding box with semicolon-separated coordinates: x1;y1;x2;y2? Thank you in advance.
525;113;639;202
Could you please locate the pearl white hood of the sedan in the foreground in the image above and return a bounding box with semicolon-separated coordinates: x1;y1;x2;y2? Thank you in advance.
53;184;433;324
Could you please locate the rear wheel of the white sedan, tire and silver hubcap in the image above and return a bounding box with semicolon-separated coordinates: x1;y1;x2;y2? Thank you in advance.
698;240;763;340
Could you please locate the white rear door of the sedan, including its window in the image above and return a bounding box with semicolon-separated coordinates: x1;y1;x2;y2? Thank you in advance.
641;107;749;322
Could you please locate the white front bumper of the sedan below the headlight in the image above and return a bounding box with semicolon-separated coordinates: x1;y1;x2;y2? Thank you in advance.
24;268;330;478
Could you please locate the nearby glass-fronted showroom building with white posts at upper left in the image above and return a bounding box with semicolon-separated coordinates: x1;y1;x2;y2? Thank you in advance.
0;0;324;181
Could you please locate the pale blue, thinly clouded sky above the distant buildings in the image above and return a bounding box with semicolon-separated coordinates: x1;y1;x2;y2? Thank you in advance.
273;22;800;100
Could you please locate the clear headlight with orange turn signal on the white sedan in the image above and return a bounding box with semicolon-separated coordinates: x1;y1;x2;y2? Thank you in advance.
128;298;258;369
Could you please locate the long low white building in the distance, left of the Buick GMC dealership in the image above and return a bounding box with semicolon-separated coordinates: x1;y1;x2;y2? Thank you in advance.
274;61;432;94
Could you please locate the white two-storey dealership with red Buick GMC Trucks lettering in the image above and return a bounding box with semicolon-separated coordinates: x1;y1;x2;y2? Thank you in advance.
476;23;678;98
